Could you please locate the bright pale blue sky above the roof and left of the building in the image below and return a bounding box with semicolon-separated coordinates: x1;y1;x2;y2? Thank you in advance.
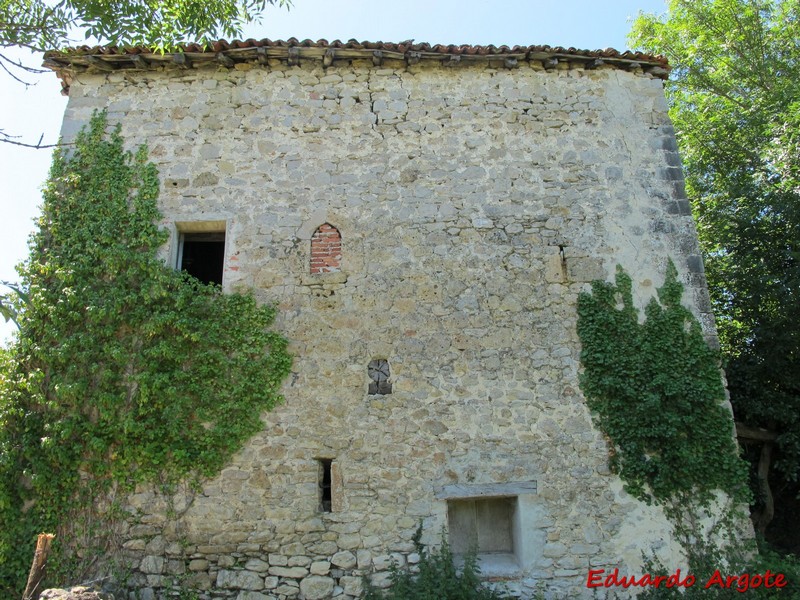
0;0;665;339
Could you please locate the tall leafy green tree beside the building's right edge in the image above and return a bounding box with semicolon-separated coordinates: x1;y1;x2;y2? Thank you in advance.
631;0;800;530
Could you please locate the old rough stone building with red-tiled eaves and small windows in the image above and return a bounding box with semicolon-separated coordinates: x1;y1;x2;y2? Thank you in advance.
46;40;715;600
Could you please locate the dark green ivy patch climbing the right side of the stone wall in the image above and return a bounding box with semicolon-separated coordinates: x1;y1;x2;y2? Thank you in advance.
578;261;748;507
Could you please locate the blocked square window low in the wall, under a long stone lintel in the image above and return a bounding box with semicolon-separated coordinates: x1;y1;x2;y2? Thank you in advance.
447;498;517;555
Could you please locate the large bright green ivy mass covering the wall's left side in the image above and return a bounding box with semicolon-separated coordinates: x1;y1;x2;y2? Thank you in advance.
0;114;291;597
